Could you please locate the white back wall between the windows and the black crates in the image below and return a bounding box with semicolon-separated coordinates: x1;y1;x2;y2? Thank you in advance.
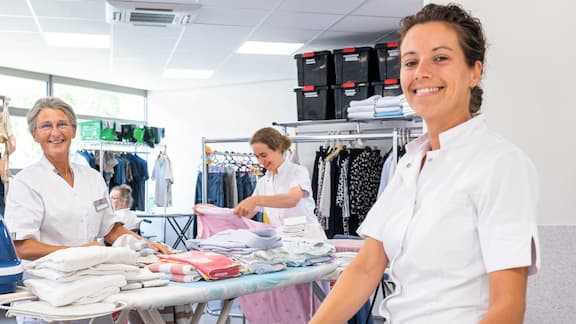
148;79;297;212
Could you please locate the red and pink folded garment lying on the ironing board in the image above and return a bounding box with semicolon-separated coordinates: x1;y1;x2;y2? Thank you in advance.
158;251;241;280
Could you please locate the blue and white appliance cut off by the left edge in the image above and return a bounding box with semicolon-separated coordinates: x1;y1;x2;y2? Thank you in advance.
0;216;24;294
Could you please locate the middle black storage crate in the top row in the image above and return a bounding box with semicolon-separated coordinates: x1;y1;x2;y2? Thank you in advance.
334;47;378;84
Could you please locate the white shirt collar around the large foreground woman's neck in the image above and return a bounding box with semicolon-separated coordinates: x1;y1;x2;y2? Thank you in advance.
406;114;487;154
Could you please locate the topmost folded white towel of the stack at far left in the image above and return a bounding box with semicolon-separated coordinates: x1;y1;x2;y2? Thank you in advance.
25;246;136;272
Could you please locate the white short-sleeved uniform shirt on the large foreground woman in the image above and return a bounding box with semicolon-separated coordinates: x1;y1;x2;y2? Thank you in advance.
358;115;540;324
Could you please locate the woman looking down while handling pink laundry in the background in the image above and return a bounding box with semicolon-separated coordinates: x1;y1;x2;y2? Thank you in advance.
234;127;318;226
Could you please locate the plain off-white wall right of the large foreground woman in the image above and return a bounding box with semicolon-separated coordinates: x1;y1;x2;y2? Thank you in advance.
432;0;576;224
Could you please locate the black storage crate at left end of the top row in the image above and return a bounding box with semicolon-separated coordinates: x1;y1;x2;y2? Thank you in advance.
294;51;334;86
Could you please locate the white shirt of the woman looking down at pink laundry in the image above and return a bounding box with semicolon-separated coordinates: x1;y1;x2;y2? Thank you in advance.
252;160;318;226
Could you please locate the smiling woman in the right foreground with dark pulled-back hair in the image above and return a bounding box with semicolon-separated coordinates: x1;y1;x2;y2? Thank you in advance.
311;4;539;324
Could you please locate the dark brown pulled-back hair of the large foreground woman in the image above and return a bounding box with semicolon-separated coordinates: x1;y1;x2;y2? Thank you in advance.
398;3;486;115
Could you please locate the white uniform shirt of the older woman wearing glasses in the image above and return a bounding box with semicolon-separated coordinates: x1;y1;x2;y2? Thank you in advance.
5;156;117;246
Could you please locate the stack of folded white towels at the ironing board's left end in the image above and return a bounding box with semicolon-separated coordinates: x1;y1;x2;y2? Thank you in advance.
24;246;168;306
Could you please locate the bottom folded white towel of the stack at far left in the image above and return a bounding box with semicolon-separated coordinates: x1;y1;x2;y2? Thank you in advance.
24;275;126;306
